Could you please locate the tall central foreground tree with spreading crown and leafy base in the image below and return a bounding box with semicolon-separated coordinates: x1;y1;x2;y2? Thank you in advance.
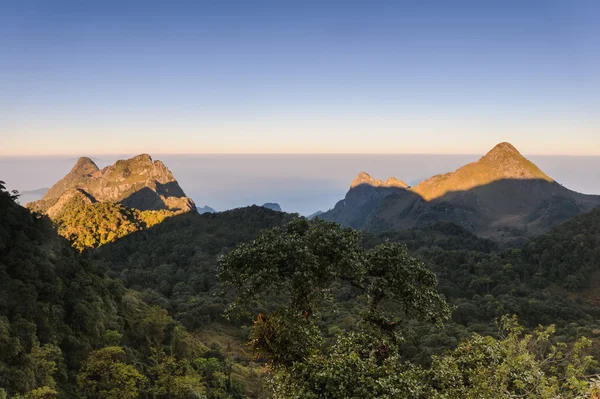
219;218;450;399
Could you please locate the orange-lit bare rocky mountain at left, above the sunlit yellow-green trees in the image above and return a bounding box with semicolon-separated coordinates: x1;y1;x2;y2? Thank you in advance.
27;154;196;217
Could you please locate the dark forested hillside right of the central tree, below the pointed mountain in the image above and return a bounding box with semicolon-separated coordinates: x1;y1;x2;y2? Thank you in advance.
363;220;600;364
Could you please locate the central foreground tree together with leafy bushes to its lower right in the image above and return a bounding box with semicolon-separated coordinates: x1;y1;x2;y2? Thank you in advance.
220;219;598;399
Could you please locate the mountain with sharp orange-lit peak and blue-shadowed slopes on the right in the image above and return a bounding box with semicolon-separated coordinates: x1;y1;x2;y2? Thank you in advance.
319;143;600;241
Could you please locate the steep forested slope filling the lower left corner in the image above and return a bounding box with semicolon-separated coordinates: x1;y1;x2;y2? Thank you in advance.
0;185;290;399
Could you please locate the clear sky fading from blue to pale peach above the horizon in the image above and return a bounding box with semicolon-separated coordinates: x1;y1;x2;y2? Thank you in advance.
0;0;600;155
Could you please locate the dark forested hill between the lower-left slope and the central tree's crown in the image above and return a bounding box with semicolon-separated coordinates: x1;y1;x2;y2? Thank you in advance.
91;206;293;328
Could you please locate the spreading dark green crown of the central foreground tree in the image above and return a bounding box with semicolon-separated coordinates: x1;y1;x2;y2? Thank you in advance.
219;218;449;328
